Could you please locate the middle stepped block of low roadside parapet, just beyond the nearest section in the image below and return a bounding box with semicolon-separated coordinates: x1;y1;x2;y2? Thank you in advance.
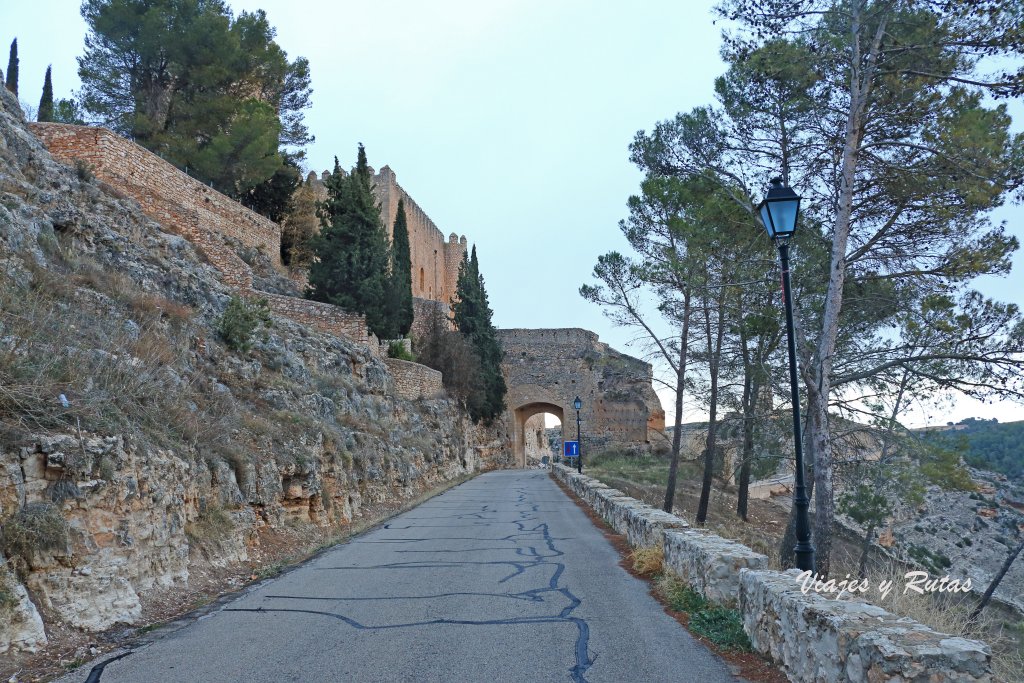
665;529;768;607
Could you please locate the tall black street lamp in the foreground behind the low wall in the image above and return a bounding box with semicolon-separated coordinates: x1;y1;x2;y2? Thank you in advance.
758;178;814;571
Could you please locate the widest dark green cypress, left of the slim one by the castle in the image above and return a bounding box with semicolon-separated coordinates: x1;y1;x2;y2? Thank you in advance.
306;144;397;339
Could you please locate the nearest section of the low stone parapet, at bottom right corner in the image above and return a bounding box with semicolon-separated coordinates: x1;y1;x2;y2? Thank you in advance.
739;569;992;683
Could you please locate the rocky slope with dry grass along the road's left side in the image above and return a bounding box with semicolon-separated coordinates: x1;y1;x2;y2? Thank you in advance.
0;88;490;653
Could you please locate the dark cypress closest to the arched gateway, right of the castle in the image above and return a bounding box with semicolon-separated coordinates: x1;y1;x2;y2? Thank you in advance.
454;246;508;424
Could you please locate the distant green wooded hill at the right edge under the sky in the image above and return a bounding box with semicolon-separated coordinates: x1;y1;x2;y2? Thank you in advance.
921;418;1024;480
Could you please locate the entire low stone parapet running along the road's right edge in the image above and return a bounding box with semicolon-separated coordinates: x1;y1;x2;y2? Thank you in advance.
553;465;993;683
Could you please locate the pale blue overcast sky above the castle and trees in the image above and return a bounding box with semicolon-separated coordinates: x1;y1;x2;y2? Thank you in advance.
0;0;1024;423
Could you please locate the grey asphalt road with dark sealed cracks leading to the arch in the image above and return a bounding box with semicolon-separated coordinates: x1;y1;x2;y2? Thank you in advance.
65;470;736;683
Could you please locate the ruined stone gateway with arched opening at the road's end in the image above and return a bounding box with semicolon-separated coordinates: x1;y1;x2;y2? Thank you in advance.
498;328;668;467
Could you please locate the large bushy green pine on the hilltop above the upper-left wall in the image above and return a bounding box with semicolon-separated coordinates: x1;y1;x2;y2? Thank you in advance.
79;0;312;201
